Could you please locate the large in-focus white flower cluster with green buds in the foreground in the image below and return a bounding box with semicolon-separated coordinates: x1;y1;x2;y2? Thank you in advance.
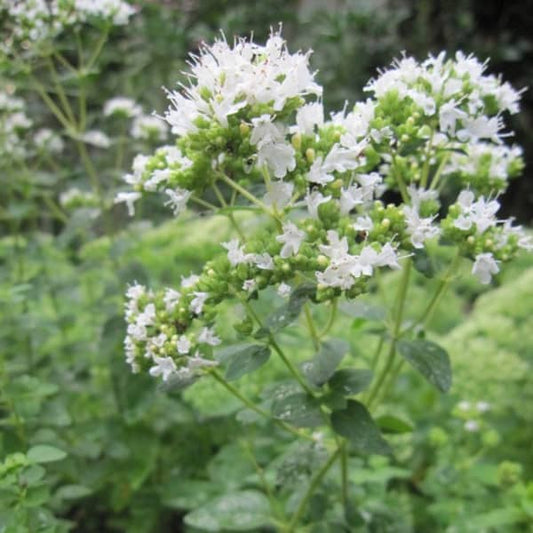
117;32;531;380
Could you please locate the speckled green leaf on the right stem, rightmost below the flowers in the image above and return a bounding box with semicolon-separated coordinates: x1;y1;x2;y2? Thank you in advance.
398;339;452;392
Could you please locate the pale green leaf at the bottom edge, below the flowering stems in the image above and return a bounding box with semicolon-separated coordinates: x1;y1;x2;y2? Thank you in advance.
184;490;270;531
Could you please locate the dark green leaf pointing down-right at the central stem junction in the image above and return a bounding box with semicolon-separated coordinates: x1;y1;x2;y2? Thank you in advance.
331;400;390;455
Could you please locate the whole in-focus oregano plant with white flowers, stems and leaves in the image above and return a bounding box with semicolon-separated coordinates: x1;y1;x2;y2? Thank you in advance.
117;31;533;532
